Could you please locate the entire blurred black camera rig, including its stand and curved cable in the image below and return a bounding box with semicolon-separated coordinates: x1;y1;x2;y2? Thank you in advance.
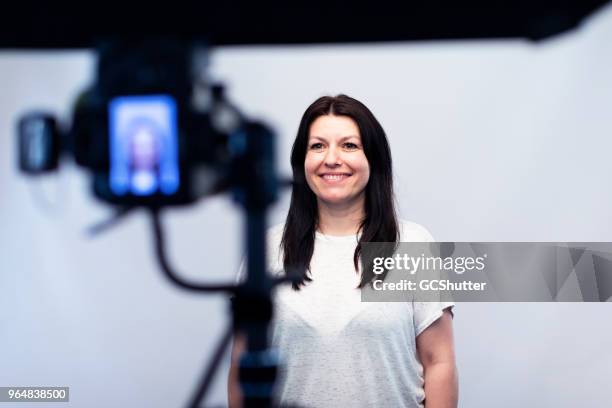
18;39;292;407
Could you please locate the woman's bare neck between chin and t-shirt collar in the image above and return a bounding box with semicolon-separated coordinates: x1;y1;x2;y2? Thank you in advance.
318;196;365;236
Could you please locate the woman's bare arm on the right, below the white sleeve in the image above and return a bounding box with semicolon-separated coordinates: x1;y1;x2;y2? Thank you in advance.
417;309;459;408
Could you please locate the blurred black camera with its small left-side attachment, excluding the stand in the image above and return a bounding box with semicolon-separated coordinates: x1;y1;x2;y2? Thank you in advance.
18;39;234;207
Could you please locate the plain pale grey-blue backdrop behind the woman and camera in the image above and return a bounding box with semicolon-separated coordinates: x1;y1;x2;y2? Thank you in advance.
0;3;612;408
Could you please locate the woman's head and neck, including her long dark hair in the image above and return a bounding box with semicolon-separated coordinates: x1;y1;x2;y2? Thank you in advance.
282;95;399;289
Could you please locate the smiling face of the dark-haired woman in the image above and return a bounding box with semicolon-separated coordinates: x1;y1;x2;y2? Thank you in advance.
304;115;370;205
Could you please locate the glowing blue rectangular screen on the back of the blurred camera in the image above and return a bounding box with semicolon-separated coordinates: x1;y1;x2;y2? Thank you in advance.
109;95;180;196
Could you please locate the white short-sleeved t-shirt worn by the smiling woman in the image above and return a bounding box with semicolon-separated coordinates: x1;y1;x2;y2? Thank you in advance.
246;221;454;408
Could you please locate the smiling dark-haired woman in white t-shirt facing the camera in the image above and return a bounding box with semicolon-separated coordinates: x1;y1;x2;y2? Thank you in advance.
229;95;458;408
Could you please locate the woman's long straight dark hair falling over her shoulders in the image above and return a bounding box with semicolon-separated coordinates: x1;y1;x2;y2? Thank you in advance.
280;95;399;290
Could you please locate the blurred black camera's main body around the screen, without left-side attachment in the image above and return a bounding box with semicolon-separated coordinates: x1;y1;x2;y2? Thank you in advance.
70;40;228;206
